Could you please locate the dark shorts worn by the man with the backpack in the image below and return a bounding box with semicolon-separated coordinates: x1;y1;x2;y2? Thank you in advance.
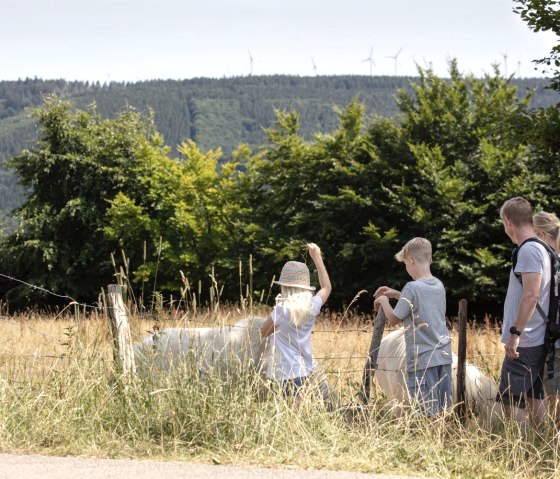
497;345;546;409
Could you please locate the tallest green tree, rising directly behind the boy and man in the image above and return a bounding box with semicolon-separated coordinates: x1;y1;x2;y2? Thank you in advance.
389;61;547;310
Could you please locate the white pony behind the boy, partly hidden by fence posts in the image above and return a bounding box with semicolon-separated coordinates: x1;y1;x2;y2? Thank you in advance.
375;328;501;419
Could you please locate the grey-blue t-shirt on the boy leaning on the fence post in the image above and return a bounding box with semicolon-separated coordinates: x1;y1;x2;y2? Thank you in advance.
394;277;452;372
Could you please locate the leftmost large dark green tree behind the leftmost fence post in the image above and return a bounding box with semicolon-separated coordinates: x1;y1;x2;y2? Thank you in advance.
1;96;165;303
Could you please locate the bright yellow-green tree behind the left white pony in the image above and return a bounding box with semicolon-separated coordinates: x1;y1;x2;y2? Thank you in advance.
105;141;249;304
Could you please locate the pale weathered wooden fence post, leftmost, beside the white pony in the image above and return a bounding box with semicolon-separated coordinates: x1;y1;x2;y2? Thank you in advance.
107;284;136;374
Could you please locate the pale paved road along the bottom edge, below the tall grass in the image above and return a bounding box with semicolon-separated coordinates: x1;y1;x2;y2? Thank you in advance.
0;454;434;479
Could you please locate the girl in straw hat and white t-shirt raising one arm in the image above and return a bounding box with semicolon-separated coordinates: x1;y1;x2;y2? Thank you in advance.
261;243;332;395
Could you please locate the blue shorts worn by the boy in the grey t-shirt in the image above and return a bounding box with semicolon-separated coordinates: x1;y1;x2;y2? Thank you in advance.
406;364;453;416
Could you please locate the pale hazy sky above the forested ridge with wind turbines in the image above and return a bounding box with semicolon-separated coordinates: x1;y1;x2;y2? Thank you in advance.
0;0;558;83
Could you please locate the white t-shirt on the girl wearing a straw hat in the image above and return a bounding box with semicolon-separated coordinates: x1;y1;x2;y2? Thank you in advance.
266;295;323;380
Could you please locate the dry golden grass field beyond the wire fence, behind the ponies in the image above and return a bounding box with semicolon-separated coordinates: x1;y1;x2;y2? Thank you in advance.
0;307;503;402
